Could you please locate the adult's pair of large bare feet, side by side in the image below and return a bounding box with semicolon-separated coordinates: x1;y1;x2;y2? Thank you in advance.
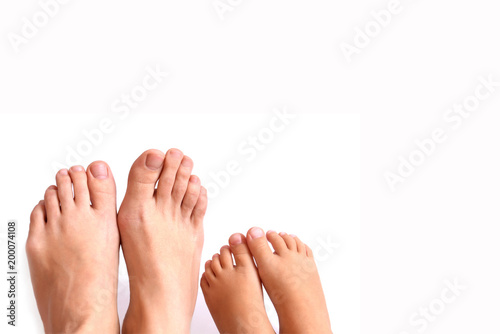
26;149;207;333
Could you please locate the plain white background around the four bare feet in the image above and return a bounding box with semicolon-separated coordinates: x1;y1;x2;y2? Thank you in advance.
0;0;500;334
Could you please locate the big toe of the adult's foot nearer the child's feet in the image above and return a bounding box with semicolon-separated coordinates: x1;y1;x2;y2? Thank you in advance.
125;150;165;201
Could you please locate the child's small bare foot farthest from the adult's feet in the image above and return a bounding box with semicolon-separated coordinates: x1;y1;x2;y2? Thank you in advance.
247;227;332;334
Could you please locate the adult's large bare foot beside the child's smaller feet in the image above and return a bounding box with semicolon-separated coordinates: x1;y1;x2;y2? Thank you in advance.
118;149;207;334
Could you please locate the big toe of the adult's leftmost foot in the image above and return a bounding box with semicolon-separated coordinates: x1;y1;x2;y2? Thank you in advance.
87;161;116;211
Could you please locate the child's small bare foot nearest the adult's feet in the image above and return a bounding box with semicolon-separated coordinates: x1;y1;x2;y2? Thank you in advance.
200;233;274;334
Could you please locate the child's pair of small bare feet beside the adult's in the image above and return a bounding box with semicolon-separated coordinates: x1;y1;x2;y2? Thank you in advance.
200;227;331;334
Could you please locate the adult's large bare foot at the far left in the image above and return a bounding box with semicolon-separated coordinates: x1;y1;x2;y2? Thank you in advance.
26;162;120;333
